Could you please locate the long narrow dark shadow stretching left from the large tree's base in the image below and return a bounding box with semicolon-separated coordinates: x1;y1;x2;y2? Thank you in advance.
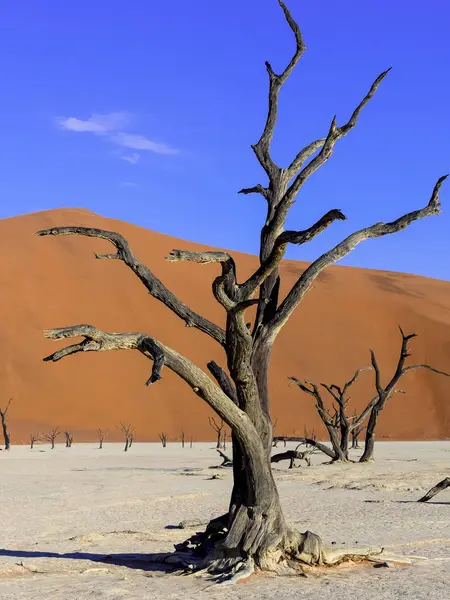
0;548;179;573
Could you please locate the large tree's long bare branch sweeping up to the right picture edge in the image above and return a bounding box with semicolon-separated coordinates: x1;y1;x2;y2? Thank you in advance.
268;175;448;336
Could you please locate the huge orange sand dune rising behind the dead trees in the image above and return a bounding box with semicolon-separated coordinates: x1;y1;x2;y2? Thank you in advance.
0;209;450;443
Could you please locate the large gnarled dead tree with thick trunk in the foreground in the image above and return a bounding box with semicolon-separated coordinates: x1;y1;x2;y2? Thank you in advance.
38;0;445;576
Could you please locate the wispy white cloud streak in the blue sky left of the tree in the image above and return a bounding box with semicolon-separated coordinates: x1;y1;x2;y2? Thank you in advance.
56;112;179;156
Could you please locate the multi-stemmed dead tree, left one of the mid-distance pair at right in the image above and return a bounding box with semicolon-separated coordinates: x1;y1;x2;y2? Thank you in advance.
288;367;371;462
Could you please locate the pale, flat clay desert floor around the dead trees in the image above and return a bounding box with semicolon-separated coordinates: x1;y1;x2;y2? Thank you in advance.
0;442;450;600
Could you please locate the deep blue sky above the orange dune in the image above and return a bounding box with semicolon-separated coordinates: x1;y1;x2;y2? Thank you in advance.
0;0;450;279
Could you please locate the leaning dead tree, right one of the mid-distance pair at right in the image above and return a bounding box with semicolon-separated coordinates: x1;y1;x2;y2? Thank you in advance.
355;327;449;462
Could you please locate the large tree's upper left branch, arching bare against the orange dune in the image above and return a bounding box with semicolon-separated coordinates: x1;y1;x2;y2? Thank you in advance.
36;227;225;346
